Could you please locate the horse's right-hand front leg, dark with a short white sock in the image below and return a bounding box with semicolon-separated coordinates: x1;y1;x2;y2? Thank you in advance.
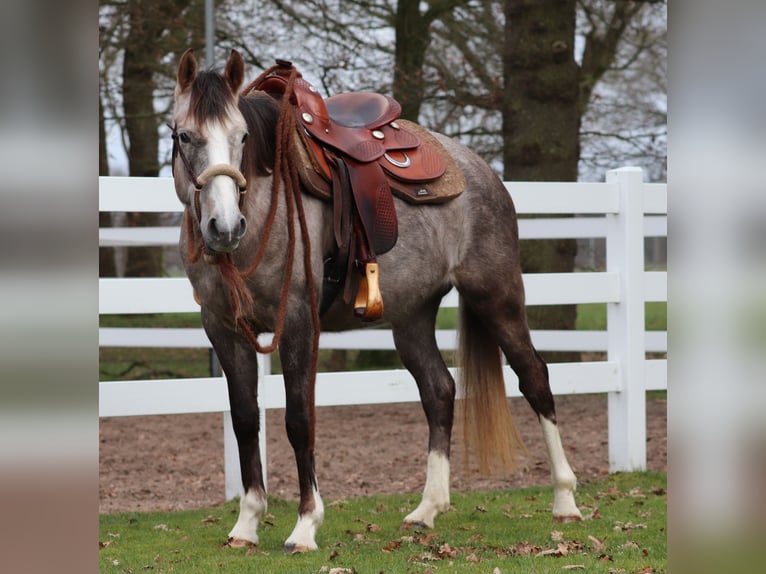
279;313;324;553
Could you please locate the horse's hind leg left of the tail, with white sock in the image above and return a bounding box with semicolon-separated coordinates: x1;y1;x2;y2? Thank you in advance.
392;299;455;529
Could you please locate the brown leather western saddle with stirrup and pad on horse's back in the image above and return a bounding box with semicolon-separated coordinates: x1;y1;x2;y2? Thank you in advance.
242;60;465;321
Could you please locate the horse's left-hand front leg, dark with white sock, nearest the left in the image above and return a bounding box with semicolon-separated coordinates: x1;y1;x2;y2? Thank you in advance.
202;309;267;547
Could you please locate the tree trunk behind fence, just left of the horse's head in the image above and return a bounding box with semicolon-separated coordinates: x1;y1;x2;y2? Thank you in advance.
122;0;163;277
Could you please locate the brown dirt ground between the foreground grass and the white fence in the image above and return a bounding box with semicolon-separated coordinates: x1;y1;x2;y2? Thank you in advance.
99;395;667;513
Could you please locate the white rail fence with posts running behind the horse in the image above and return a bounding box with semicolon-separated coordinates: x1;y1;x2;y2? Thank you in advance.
99;168;667;498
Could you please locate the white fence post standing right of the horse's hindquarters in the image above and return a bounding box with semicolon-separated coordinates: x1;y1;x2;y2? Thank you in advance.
606;167;646;472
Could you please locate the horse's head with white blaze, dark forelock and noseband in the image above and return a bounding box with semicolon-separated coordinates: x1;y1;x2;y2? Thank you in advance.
172;50;248;253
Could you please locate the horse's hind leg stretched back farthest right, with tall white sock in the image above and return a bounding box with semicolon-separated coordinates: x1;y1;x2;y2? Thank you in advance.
461;274;582;522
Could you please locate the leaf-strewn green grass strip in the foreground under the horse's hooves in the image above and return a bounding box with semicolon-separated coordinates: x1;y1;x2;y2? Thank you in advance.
99;473;667;574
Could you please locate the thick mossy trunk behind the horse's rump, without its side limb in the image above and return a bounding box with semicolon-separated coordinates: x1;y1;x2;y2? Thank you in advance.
503;0;580;362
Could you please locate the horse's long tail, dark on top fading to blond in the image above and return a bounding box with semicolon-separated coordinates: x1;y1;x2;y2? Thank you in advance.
458;298;525;474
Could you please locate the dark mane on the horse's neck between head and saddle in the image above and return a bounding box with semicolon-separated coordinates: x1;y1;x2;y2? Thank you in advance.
239;92;279;179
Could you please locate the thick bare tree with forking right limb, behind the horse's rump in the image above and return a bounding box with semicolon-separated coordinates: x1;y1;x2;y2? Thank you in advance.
503;0;664;360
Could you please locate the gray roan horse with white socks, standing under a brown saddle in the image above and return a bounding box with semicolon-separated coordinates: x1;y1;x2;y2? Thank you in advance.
172;50;581;552
